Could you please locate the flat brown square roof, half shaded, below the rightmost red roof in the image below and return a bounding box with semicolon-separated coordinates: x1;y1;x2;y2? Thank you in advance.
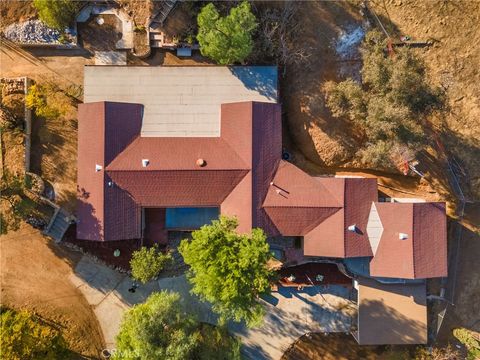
355;278;427;345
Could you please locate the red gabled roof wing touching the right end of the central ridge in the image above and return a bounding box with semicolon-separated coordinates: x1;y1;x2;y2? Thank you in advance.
221;102;282;236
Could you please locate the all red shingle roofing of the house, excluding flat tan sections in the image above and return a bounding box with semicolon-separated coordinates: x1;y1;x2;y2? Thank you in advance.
77;96;446;278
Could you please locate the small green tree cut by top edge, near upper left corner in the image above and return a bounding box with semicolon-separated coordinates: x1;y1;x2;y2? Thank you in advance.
33;0;78;31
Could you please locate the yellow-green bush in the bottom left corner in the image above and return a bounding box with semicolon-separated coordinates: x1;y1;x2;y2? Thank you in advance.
0;308;67;360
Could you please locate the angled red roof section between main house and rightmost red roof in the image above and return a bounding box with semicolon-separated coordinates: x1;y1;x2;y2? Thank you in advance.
263;167;377;258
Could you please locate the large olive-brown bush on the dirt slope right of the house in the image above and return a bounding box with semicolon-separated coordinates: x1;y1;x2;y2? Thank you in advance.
324;31;444;169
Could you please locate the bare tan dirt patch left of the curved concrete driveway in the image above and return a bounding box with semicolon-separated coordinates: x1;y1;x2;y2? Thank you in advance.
0;225;103;358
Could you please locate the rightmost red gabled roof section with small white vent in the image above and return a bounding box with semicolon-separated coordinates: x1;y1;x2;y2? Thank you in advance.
370;203;447;279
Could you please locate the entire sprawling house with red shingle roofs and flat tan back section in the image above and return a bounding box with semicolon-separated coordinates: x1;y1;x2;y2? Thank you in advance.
77;66;447;343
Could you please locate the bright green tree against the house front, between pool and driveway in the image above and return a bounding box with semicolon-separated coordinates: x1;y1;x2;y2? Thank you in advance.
179;216;272;326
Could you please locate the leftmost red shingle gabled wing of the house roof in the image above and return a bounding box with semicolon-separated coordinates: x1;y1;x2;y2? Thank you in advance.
77;102;142;240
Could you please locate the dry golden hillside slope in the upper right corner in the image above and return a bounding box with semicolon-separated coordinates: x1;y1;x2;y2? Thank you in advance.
372;0;480;200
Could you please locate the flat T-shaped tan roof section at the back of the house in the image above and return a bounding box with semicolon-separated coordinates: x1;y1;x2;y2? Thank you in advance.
84;66;278;137
